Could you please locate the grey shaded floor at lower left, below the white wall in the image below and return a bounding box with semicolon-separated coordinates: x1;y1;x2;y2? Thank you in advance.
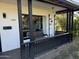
0;49;21;59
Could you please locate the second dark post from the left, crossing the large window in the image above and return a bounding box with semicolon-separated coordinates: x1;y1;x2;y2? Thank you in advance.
28;0;34;59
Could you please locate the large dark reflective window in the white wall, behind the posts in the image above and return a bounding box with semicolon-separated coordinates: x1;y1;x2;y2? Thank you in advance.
22;14;43;37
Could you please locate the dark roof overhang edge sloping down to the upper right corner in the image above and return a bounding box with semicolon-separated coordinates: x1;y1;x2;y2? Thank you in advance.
38;0;79;10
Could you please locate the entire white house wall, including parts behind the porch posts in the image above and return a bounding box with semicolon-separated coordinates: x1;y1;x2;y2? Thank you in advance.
0;0;64;52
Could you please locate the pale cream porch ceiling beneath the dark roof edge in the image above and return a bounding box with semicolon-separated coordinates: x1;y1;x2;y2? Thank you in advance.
0;0;65;11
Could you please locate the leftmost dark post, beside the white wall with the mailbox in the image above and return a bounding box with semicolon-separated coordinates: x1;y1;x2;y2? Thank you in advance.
17;0;24;59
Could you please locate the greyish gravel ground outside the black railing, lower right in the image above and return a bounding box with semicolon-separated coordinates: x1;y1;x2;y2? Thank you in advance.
35;37;79;59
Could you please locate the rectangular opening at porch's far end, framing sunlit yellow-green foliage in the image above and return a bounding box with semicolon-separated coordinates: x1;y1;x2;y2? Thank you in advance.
55;13;67;34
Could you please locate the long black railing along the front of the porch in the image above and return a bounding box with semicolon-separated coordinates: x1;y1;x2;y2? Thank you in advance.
22;33;71;59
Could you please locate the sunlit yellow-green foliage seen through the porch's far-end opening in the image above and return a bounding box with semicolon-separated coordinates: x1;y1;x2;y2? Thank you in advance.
56;14;66;32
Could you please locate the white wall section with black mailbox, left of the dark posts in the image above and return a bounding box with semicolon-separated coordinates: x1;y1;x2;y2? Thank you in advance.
0;2;20;52
